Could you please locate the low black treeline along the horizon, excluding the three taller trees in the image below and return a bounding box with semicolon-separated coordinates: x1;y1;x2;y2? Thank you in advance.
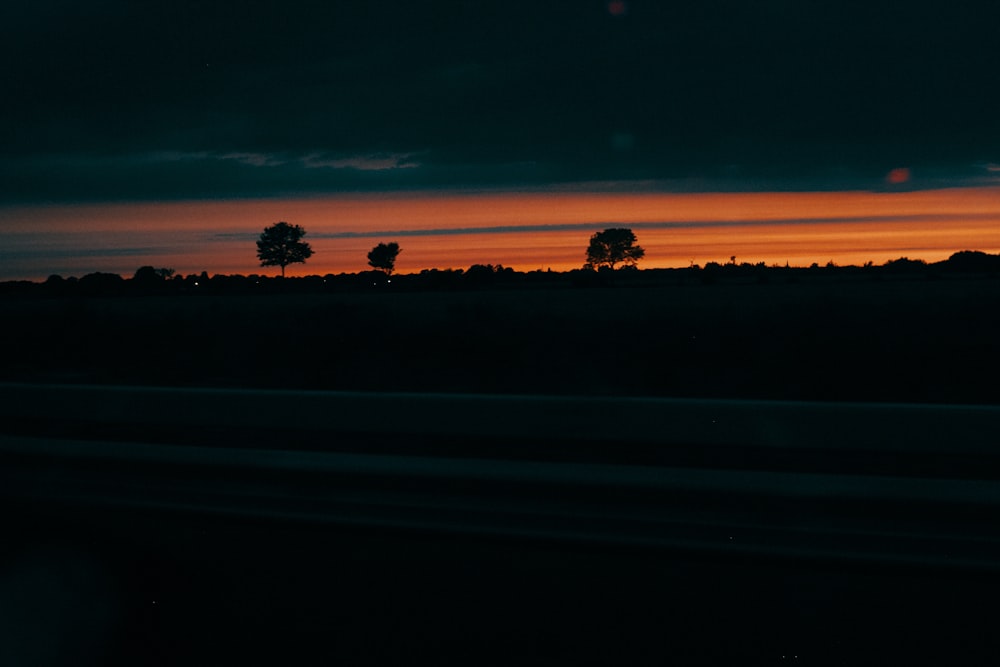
0;250;1000;296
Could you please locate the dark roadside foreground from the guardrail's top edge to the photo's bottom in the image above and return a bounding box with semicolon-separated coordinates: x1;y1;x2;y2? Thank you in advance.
0;385;1000;665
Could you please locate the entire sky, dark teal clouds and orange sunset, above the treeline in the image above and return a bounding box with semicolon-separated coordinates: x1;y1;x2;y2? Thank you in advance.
0;0;1000;280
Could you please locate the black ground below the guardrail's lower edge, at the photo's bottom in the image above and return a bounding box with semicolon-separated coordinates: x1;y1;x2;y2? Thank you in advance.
11;496;1000;666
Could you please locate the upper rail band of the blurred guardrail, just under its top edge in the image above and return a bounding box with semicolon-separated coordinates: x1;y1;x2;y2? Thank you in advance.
0;383;1000;453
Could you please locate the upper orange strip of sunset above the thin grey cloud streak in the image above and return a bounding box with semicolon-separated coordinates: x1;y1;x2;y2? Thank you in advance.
6;188;1000;233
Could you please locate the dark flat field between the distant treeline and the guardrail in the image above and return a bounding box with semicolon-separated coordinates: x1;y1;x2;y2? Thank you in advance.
0;275;1000;404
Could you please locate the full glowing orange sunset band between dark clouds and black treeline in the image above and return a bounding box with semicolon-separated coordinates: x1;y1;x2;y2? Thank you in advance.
0;187;1000;280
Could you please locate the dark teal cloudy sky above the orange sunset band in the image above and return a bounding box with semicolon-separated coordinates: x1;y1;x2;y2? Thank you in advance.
0;0;1000;203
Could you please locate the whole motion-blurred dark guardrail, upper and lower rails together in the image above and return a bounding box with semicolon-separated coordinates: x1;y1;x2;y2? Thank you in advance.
0;384;1000;570
